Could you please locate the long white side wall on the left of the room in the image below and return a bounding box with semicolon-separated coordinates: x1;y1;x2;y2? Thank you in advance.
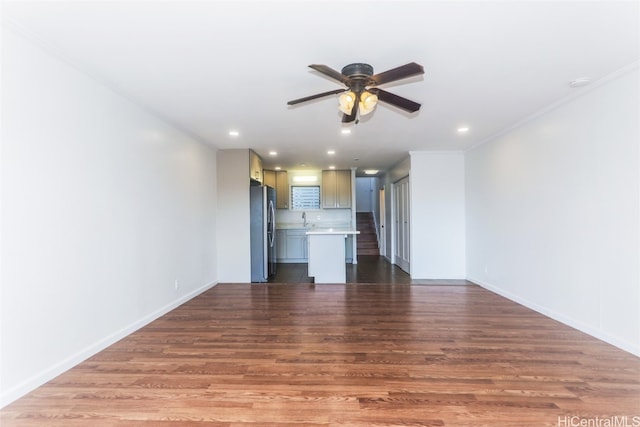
0;28;217;406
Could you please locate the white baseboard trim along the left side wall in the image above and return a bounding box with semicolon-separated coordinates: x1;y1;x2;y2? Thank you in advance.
0;282;218;409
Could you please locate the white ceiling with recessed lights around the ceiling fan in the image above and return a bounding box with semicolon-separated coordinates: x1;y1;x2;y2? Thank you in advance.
2;0;640;175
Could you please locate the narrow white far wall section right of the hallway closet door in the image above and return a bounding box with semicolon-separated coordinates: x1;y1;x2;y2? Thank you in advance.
409;151;465;279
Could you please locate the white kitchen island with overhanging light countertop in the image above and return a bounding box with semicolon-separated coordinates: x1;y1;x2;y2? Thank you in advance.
307;228;360;283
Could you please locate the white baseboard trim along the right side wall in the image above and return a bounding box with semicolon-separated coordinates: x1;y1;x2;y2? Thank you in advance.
467;277;640;357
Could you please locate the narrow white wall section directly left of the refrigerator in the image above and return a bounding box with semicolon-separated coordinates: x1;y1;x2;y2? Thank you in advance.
217;149;251;283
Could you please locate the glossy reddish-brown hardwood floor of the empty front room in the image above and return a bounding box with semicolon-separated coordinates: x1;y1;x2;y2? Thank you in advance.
0;284;640;427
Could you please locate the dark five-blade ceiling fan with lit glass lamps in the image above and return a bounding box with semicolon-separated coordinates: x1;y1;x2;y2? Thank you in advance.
287;62;424;123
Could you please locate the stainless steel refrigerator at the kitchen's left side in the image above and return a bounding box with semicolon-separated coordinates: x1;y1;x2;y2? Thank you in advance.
250;185;276;282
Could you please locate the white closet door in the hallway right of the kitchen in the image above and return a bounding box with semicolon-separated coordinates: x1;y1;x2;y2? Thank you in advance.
393;177;411;273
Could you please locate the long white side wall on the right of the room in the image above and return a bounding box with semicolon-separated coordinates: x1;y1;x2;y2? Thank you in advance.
464;68;640;355
